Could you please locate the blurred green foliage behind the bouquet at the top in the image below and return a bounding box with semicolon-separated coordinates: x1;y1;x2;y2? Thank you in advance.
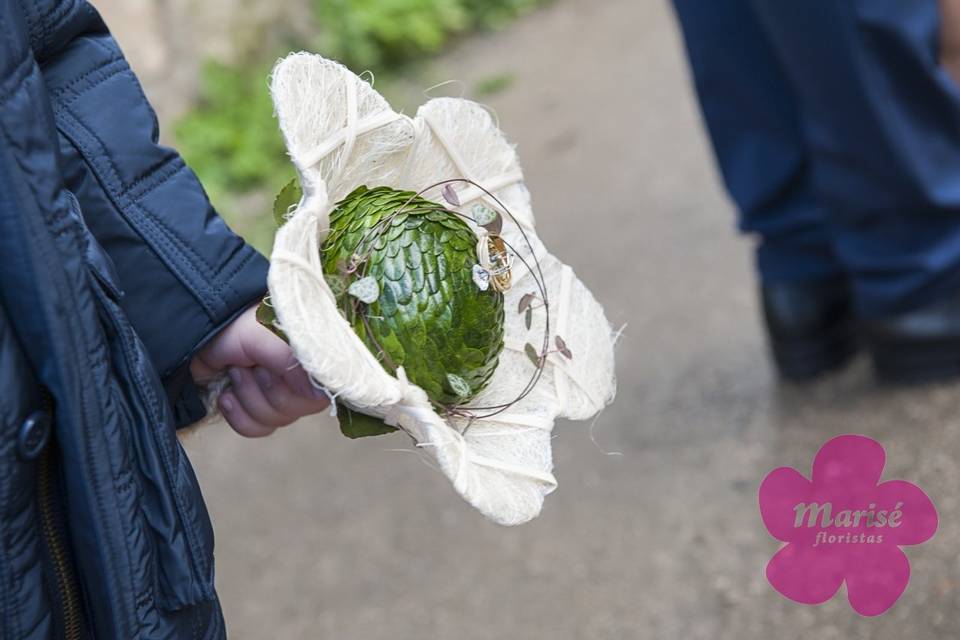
174;0;545;252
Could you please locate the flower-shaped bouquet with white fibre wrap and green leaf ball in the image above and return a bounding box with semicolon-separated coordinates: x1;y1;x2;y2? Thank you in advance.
259;53;616;525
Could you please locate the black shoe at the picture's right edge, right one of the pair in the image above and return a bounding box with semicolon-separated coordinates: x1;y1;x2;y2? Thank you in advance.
862;295;960;383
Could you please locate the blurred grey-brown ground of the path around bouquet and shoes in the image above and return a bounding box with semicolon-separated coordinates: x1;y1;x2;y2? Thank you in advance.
99;0;960;640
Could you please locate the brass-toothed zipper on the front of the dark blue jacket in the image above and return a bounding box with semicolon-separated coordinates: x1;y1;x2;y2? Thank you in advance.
37;392;83;640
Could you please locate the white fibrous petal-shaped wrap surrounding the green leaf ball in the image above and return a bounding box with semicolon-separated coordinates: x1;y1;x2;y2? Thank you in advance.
269;53;616;525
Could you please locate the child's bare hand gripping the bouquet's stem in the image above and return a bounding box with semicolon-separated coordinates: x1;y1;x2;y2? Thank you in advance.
190;307;330;438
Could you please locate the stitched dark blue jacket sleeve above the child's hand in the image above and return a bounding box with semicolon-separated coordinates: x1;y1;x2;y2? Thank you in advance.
29;0;267;425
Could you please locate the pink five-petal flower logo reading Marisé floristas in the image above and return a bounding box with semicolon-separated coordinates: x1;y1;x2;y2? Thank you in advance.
760;435;937;616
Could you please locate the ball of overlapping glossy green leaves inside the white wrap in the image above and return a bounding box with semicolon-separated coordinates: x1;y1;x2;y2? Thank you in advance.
321;186;504;406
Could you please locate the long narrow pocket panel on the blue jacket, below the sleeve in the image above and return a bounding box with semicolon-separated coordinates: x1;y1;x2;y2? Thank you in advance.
73;199;215;610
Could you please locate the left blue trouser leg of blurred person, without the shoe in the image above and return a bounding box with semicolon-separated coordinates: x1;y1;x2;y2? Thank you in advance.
674;0;840;284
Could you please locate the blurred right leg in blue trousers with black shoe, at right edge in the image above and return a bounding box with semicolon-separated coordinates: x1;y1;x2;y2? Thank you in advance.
751;0;960;379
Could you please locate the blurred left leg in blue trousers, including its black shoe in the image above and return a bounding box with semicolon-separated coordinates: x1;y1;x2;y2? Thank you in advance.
674;0;855;379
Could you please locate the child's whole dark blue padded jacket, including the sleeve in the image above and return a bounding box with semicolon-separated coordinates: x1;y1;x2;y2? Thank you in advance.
0;0;266;640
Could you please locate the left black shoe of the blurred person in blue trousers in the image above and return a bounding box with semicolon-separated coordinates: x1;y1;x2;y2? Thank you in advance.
760;278;860;381
